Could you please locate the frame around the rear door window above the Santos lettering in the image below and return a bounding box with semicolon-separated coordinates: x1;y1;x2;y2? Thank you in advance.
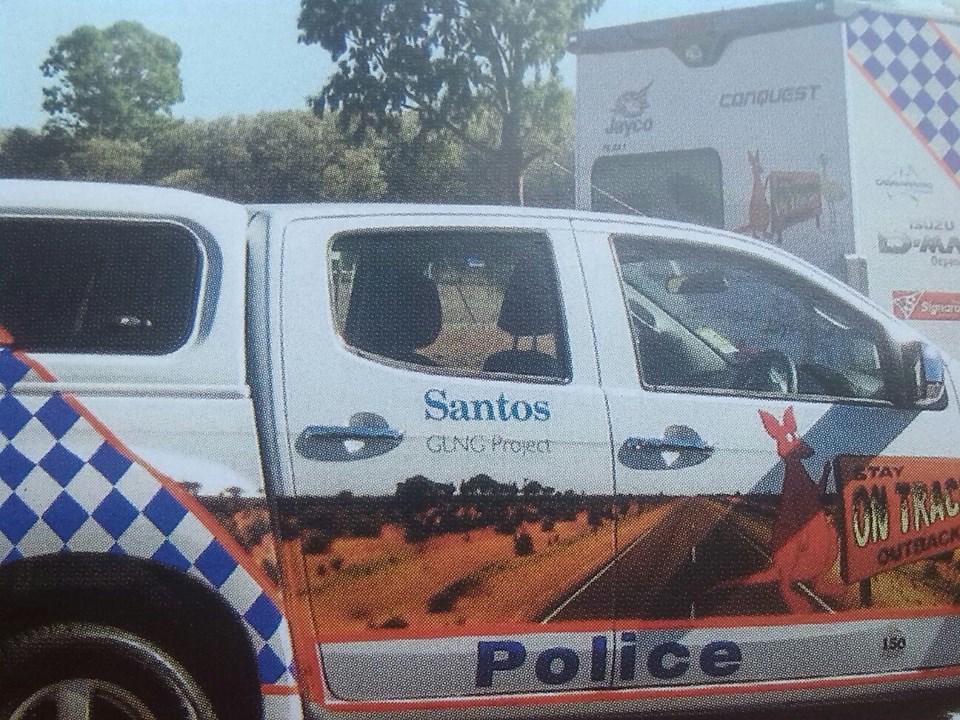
324;225;574;385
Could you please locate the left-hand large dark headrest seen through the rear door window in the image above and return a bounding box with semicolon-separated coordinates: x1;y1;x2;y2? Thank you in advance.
343;271;442;360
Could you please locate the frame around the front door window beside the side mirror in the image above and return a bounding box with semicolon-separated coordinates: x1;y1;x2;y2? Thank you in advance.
607;233;904;409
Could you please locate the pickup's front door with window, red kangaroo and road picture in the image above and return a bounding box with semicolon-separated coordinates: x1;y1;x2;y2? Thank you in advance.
577;224;960;686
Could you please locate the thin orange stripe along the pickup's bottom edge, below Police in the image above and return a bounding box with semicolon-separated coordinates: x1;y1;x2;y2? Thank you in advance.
314;666;960;712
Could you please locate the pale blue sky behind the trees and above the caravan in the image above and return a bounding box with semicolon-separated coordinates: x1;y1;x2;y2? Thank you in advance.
0;0;796;127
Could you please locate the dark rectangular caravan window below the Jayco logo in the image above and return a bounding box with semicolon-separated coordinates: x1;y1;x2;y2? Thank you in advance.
591;148;723;227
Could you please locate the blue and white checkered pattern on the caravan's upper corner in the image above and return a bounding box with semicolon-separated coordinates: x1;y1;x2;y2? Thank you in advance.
847;10;960;179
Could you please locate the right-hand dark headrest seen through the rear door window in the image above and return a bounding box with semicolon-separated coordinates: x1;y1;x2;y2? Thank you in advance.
497;260;558;336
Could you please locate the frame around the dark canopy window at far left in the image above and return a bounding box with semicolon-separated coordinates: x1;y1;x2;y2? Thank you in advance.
0;213;209;358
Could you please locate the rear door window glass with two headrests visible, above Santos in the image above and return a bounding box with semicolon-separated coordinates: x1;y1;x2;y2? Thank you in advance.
329;231;569;381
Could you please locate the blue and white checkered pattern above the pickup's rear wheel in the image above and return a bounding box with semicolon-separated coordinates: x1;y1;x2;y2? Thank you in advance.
0;347;293;685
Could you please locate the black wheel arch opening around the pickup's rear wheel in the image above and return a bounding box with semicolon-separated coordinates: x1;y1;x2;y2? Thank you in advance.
0;553;263;720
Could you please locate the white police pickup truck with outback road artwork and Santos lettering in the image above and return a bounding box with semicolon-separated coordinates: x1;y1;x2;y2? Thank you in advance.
0;181;960;720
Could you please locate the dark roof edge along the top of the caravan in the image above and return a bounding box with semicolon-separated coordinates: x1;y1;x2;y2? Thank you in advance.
568;0;960;59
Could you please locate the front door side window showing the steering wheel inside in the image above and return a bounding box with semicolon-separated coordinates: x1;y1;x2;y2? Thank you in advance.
614;237;889;400
